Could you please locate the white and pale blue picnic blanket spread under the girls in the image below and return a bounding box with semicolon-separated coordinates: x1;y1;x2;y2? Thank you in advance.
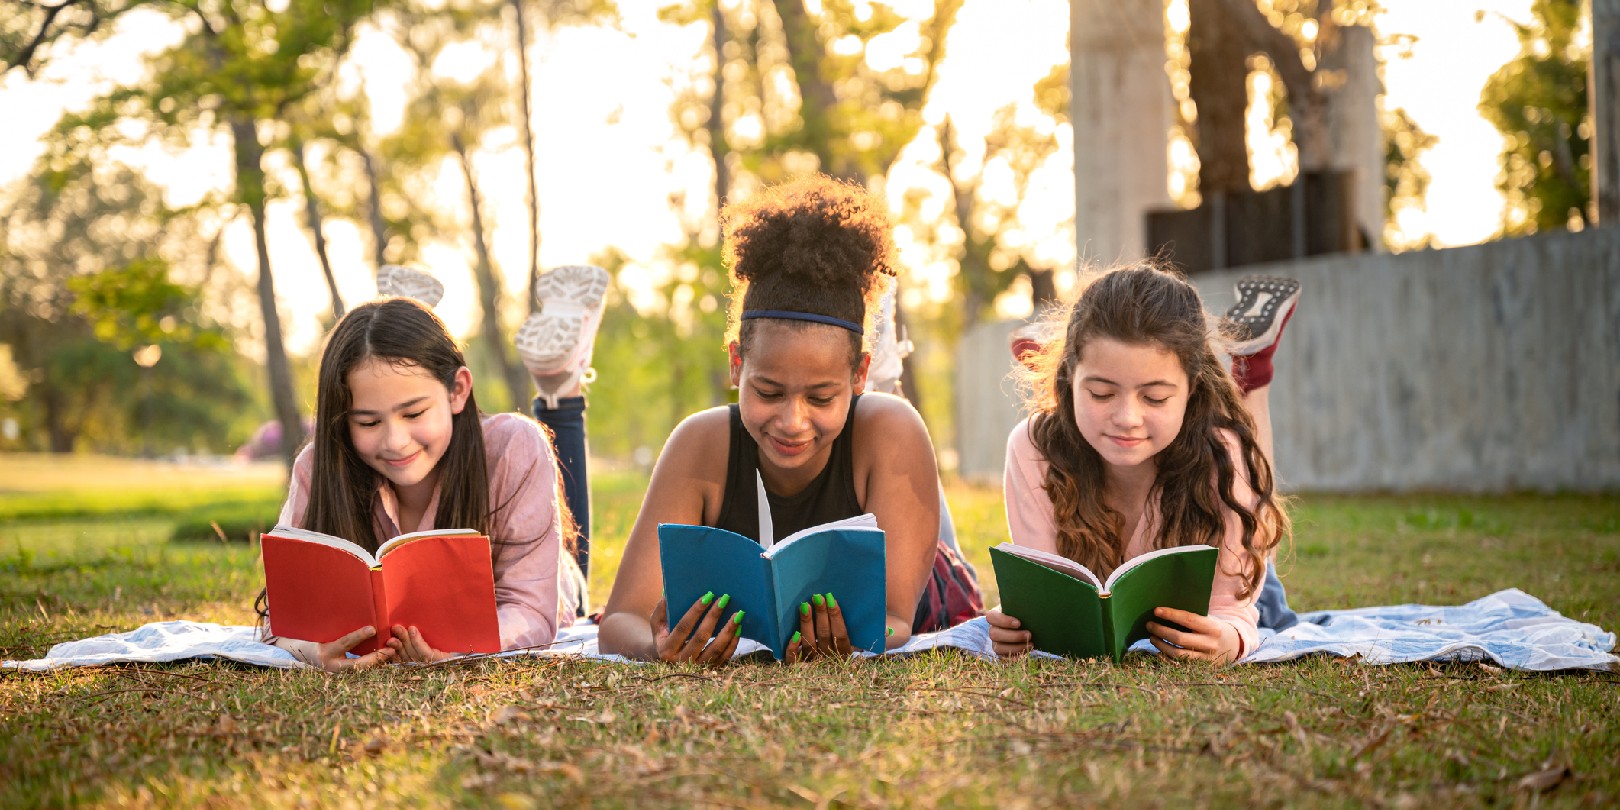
0;588;1620;672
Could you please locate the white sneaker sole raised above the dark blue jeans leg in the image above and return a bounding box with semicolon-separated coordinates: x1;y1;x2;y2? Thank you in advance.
517;264;611;408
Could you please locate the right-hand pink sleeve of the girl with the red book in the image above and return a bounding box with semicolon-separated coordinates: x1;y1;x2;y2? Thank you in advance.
484;413;573;650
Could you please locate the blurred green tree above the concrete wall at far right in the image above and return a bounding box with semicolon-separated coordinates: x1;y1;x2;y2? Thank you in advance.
1479;0;1592;237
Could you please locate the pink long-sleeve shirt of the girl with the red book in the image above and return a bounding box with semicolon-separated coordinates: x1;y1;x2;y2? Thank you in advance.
280;413;580;650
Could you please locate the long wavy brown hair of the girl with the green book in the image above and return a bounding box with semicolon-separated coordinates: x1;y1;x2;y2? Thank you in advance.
1025;262;1291;598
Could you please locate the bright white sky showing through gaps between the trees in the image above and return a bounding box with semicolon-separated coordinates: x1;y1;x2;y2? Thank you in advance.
0;0;1529;350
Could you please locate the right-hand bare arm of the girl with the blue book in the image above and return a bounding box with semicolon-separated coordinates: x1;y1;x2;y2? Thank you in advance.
855;394;940;648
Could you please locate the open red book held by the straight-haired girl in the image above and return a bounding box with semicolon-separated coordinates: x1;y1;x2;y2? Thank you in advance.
261;527;501;654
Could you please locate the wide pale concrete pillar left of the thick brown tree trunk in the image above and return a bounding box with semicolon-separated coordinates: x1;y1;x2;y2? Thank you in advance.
1069;0;1175;264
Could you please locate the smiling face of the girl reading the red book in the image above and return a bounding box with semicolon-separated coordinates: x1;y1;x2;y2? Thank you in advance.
348;358;473;499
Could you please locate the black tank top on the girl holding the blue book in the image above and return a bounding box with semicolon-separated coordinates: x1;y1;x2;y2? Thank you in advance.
714;394;863;541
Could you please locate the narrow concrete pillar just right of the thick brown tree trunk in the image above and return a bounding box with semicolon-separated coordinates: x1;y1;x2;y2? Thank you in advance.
1317;26;1385;251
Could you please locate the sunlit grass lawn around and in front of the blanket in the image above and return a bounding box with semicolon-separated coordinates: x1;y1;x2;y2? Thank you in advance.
0;455;1620;807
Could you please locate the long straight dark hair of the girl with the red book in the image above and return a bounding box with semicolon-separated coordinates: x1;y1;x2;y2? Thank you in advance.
300;298;491;551
